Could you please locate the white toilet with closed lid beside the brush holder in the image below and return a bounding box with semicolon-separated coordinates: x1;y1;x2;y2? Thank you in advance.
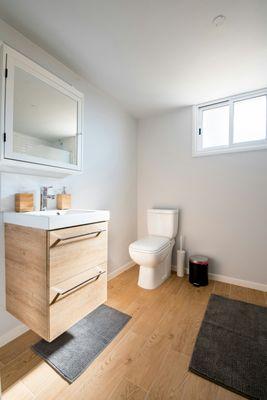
129;209;178;289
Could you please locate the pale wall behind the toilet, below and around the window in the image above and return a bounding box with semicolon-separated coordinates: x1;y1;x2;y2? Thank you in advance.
138;107;267;284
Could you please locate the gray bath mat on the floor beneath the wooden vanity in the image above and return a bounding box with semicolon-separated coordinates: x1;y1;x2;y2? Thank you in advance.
32;304;131;383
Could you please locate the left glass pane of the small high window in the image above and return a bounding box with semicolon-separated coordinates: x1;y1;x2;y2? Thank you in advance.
202;105;229;149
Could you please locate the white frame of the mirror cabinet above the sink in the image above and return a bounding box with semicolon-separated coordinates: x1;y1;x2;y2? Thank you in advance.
0;43;84;177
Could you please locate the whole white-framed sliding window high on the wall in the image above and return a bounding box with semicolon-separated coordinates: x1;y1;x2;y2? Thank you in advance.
193;89;267;155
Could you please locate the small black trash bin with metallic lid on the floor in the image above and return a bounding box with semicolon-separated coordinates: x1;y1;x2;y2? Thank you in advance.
189;256;209;286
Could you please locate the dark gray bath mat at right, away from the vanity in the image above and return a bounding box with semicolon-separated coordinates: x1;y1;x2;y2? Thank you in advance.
189;295;267;400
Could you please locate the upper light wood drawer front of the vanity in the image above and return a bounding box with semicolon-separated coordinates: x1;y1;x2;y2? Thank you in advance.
48;222;107;287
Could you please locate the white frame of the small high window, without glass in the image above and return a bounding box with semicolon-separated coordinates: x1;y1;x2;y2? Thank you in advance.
192;88;267;157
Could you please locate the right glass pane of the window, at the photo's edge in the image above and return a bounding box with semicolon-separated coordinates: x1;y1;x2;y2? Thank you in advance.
234;96;266;143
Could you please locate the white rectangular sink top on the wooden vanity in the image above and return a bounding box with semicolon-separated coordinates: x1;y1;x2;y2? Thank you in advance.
4;210;110;230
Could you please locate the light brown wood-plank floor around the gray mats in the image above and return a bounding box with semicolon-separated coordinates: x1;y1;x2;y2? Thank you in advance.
0;267;267;400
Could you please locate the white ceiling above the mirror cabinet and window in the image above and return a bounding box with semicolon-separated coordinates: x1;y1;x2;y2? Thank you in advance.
0;0;267;117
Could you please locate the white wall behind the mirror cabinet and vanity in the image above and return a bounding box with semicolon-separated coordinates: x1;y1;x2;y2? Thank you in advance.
0;20;137;343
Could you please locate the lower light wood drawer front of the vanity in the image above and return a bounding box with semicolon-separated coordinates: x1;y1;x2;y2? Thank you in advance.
49;268;107;341
